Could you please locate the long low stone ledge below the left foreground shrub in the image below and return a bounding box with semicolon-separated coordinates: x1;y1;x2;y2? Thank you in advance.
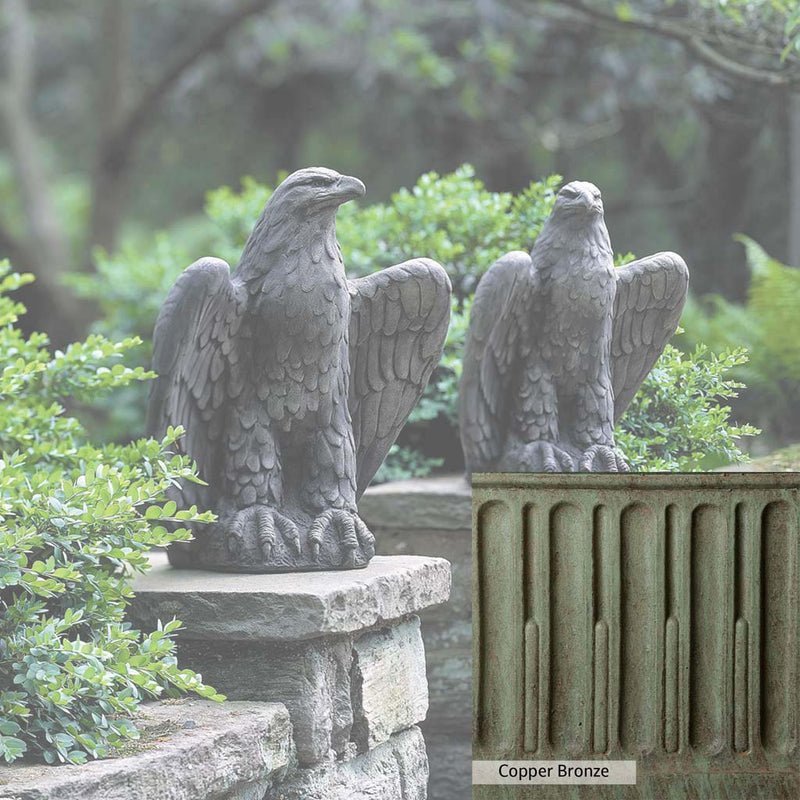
0;700;292;800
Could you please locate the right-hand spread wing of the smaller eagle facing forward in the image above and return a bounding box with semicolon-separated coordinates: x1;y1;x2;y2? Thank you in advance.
611;253;689;424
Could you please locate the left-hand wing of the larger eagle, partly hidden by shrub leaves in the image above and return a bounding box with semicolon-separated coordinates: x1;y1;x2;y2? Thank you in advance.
147;258;244;502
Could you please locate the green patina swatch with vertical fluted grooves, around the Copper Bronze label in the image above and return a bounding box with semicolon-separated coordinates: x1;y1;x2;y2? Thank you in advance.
473;473;800;800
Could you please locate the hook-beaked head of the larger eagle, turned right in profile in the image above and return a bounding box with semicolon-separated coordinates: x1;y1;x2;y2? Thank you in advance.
267;167;366;216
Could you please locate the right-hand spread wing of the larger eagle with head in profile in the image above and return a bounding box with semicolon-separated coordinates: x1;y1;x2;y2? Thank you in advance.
349;258;451;497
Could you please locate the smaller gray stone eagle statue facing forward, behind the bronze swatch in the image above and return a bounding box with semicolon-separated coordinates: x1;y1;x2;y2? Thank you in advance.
459;181;689;473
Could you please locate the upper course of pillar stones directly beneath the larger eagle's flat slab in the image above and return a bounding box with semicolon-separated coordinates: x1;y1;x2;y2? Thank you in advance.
178;617;428;766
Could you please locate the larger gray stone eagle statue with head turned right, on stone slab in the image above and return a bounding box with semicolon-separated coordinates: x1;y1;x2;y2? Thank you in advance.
147;168;450;572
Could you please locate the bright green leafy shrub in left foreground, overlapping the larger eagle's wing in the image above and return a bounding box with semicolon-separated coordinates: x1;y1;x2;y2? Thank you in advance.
0;263;221;763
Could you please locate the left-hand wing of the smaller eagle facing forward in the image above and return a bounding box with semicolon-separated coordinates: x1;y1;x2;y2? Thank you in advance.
458;250;535;473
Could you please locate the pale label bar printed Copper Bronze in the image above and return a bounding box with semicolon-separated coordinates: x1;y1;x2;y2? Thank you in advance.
472;760;636;786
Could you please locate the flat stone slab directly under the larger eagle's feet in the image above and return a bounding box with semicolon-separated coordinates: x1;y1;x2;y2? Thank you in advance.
129;553;450;642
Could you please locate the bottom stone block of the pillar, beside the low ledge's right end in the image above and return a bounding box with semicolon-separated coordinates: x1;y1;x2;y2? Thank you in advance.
264;728;428;800
